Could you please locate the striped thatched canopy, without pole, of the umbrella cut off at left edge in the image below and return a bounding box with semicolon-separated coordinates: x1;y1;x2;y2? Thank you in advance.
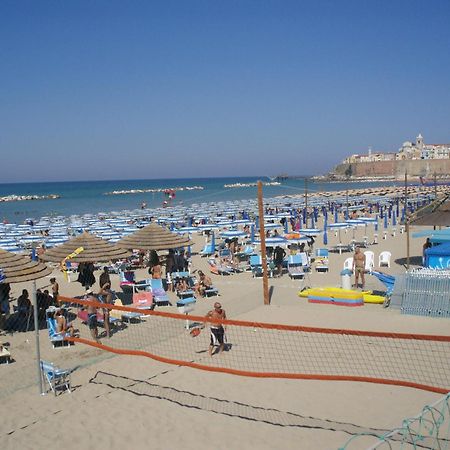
0;249;52;283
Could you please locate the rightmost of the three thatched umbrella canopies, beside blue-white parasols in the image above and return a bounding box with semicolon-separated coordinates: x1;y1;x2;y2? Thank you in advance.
116;223;192;250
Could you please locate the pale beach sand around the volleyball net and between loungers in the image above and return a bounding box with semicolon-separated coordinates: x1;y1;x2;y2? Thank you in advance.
0;221;450;449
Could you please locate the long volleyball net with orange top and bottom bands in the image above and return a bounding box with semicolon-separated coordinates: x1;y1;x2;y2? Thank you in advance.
59;297;450;393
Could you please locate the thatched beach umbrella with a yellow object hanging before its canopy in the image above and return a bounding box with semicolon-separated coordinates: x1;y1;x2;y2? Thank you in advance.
40;232;131;263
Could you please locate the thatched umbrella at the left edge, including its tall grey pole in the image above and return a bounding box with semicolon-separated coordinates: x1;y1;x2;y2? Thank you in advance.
0;249;52;394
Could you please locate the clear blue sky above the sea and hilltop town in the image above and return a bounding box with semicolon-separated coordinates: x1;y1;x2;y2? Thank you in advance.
0;0;450;182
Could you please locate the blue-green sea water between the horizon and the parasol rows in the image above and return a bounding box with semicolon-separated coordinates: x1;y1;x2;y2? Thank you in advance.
0;177;393;222
